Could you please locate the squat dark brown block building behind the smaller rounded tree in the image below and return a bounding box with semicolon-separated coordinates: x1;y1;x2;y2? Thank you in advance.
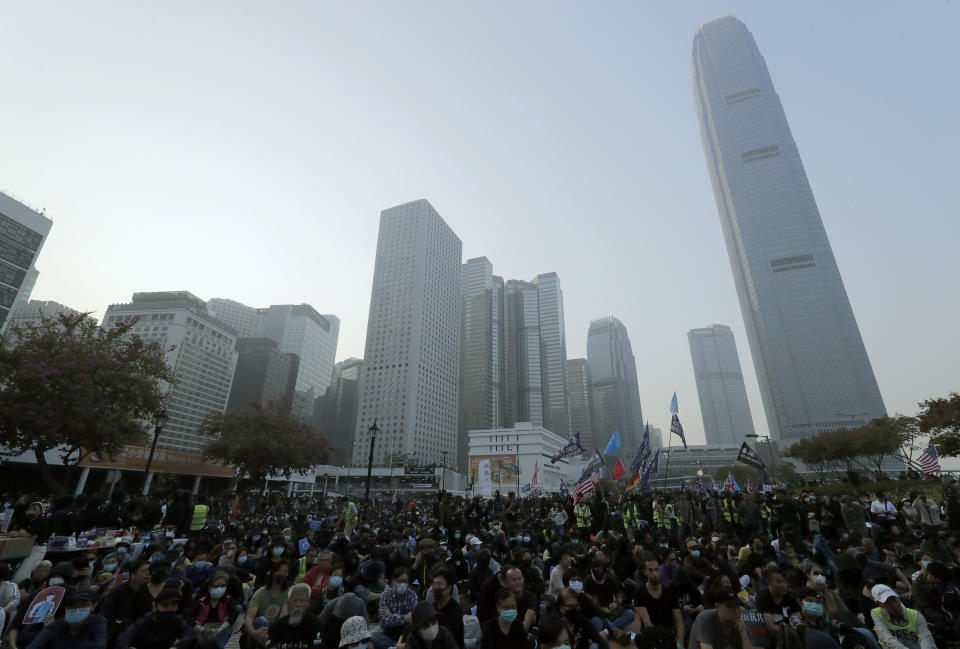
227;338;300;412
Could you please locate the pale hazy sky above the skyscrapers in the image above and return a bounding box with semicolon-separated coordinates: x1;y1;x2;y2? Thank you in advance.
0;0;960;450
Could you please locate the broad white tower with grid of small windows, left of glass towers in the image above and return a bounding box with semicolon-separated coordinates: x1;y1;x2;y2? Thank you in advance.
353;200;462;464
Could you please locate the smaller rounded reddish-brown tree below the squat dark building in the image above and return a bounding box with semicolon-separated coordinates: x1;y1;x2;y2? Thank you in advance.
197;399;330;483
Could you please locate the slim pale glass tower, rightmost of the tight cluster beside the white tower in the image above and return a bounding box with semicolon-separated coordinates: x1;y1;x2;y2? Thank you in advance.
532;273;570;437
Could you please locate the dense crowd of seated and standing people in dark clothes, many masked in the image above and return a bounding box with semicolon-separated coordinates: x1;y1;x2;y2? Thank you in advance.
0;480;960;649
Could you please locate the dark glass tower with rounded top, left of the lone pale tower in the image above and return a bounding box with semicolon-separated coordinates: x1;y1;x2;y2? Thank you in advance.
587;316;643;452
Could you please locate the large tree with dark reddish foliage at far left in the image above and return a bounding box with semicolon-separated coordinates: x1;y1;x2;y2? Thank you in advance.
0;313;174;493
